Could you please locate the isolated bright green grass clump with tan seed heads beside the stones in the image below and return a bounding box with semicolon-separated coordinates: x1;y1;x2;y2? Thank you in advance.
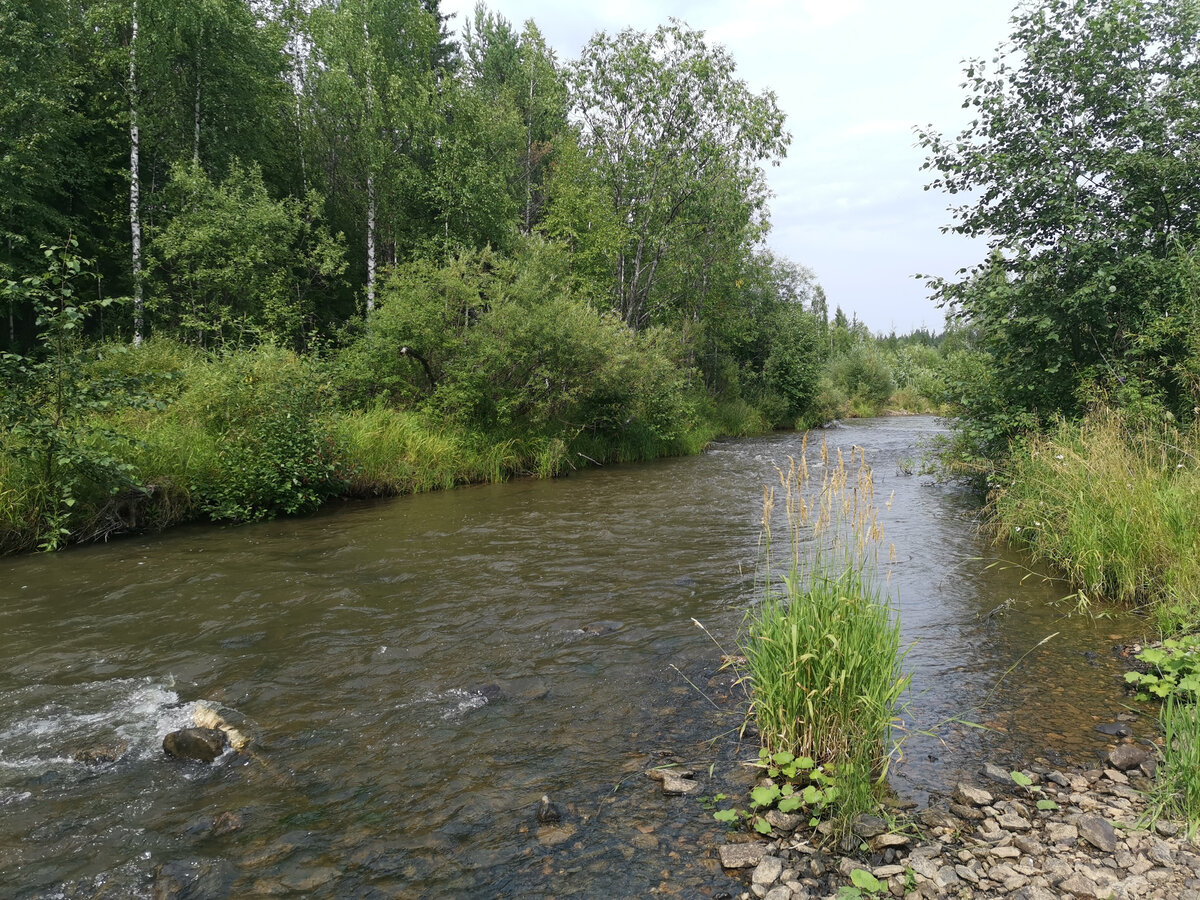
744;440;908;818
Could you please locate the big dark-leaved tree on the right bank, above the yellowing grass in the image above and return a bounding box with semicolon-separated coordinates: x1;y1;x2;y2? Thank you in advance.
922;0;1200;458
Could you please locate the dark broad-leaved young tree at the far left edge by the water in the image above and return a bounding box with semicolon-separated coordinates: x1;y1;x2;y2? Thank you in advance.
0;240;157;550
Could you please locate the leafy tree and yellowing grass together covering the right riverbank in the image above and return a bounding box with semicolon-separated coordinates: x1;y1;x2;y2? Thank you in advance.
920;0;1200;829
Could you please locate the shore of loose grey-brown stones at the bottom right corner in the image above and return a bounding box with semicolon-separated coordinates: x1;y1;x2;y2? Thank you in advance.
719;743;1200;900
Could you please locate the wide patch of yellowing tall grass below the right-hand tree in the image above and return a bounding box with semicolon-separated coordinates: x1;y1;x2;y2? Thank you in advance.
990;408;1200;632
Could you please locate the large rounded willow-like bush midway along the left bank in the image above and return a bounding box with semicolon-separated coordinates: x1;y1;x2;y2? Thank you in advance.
341;240;702;453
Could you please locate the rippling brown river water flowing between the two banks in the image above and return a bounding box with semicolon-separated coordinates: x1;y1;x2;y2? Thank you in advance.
0;419;1148;898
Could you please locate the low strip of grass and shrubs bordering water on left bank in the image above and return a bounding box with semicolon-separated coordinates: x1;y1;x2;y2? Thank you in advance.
0;332;769;552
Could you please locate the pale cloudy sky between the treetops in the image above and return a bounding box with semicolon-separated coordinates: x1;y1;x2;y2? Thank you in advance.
440;0;1016;334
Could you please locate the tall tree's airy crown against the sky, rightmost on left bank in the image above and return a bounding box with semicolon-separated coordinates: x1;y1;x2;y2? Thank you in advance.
569;22;791;328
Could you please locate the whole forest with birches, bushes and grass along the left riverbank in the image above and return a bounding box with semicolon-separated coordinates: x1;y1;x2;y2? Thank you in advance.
0;0;961;551
